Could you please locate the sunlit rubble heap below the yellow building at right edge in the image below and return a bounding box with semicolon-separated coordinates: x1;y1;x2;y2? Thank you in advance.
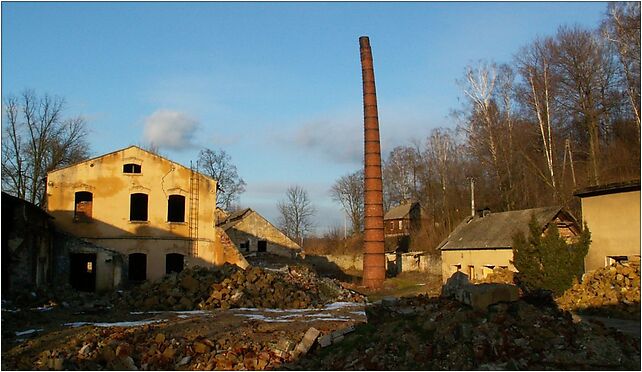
557;261;640;319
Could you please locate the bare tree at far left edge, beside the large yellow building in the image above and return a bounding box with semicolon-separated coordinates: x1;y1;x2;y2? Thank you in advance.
2;91;89;207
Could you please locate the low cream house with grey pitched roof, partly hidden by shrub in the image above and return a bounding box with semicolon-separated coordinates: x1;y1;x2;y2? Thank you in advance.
437;206;580;282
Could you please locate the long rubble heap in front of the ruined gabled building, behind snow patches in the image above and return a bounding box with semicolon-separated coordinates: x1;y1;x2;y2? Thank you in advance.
118;265;364;310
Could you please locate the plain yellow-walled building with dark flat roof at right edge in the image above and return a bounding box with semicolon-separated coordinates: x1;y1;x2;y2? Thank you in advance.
575;180;640;271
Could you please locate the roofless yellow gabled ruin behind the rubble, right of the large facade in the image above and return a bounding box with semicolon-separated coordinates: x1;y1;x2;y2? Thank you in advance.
217;208;301;257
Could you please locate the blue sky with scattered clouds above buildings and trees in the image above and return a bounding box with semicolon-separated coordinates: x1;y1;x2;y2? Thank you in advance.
2;2;607;232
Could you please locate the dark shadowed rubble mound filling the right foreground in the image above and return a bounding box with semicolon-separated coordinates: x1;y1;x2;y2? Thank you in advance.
288;296;640;370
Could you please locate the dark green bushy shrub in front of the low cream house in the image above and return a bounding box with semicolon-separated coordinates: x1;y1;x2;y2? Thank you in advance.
512;217;591;295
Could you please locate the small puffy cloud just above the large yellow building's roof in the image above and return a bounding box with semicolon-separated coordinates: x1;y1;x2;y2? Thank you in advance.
144;109;199;150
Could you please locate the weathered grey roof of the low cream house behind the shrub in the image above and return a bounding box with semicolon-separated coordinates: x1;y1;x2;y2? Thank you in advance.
437;206;575;250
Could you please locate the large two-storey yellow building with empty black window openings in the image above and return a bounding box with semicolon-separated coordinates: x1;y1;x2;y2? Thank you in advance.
47;146;247;290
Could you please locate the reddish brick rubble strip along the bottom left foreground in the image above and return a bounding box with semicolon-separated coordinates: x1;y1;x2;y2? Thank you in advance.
16;324;319;370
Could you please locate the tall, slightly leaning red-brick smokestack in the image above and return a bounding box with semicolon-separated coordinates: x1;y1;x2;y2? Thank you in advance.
359;36;386;288
